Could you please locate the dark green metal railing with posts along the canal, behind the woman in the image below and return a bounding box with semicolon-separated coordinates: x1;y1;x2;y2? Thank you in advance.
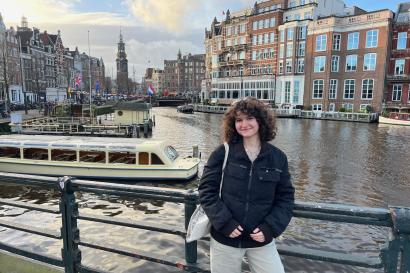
0;173;410;273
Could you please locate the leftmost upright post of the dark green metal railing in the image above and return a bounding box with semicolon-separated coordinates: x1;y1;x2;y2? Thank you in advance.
58;176;81;273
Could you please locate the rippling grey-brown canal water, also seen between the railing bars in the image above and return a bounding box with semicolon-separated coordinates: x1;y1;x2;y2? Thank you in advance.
0;108;410;273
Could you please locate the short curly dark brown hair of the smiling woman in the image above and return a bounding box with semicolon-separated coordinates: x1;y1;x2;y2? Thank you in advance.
221;97;276;143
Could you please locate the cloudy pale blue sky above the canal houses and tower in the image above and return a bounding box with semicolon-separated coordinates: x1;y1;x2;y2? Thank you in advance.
0;0;404;81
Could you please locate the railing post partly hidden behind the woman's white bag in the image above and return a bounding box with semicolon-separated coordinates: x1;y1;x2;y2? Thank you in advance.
184;189;198;263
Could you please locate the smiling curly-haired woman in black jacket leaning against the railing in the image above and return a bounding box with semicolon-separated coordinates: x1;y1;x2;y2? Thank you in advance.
199;97;294;273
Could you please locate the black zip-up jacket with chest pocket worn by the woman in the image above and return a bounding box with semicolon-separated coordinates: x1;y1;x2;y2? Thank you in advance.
199;139;294;248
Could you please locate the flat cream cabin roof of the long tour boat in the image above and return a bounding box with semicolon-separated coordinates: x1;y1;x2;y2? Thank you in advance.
0;135;167;151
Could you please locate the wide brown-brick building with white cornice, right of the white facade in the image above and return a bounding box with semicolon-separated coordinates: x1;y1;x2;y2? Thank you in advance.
304;10;393;112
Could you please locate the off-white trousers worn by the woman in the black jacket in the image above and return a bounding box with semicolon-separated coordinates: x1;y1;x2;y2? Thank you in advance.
210;237;285;273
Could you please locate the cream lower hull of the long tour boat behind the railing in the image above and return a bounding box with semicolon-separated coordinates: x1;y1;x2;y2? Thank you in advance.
0;160;198;181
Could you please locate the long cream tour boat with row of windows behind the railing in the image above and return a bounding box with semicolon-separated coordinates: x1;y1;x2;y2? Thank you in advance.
0;135;199;180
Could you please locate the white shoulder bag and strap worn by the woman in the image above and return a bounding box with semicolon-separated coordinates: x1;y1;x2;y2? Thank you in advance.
186;142;229;240
